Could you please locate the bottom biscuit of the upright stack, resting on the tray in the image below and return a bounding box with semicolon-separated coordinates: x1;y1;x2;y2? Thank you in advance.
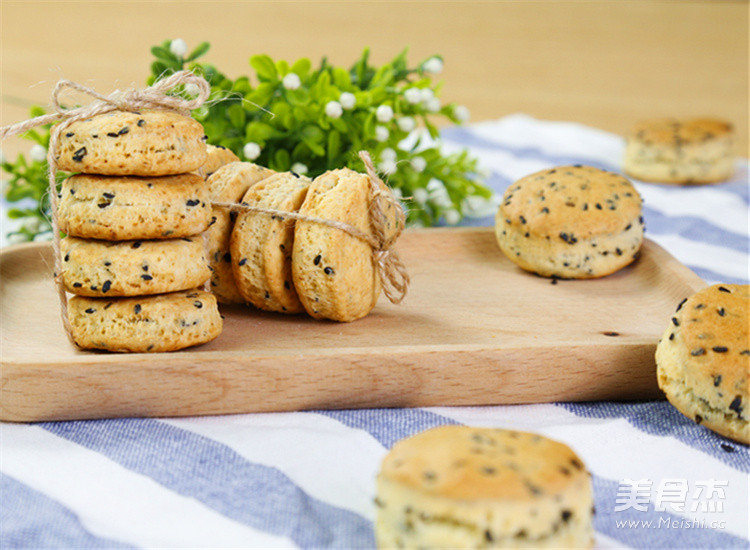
68;289;222;352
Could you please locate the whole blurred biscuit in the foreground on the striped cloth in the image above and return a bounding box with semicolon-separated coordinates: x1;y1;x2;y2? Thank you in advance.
375;426;594;548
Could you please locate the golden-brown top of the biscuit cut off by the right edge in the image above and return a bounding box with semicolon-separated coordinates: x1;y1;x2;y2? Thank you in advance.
672;284;750;418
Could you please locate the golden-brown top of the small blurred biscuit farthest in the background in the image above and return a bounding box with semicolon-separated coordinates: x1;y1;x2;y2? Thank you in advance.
628;118;733;146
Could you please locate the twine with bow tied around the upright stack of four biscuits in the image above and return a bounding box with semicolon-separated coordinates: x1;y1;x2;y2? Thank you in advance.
0;71;211;344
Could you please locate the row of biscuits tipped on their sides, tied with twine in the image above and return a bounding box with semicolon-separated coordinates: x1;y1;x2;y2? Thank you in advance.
207;162;401;322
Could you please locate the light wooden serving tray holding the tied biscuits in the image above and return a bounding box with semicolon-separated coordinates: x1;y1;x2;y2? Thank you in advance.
0;228;705;421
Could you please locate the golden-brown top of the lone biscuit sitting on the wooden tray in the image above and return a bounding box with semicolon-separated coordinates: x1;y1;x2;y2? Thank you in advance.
498;165;642;242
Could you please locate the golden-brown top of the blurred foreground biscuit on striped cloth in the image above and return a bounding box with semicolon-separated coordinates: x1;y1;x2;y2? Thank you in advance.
381;426;588;501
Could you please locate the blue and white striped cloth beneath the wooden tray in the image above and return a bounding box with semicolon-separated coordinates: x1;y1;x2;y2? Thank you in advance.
0;115;750;549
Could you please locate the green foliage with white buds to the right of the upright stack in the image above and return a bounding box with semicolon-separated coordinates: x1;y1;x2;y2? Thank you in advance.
149;40;491;225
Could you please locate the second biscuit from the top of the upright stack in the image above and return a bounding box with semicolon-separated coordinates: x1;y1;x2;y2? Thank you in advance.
58;174;211;241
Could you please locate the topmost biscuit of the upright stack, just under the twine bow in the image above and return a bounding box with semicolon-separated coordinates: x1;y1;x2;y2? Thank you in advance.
57;111;206;176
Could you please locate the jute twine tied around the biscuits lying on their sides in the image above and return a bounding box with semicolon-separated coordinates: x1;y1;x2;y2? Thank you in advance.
212;151;409;304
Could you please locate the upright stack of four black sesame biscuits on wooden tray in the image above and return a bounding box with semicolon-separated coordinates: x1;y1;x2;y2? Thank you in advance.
56;111;222;352
